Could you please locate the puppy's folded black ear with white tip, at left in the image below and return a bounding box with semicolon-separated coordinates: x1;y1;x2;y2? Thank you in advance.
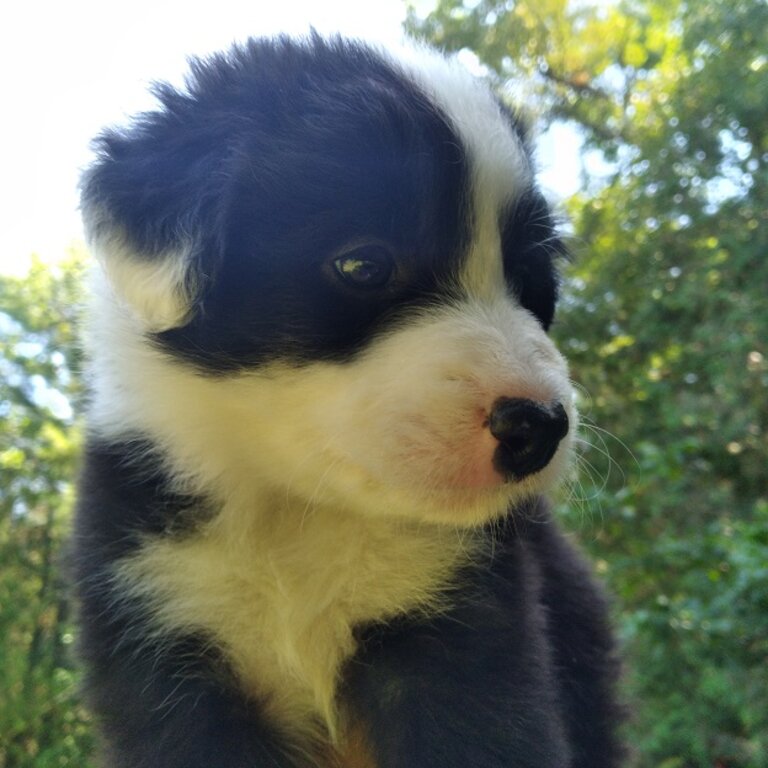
81;80;228;331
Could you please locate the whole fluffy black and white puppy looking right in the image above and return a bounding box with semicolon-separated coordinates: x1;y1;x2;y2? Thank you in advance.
75;36;619;768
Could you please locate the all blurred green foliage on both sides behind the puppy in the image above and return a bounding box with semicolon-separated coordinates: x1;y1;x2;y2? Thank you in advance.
0;0;768;768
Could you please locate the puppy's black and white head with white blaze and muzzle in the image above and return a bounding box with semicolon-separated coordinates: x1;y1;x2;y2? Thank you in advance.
83;38;575;524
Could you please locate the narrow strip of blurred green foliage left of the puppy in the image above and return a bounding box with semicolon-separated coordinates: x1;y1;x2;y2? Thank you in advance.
0;253;92;768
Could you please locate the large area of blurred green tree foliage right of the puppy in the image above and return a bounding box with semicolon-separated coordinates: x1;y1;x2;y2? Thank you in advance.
409;0;768;768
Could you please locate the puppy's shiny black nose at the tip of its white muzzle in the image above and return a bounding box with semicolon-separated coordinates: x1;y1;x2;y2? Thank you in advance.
488;397;568;480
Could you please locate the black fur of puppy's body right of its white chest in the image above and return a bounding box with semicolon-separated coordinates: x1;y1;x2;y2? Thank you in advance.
345;501;622;768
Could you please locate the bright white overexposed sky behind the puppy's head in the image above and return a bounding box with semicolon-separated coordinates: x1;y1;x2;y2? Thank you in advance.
0;0;579;274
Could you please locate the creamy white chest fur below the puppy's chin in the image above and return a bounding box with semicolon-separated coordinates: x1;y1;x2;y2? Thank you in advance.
118;486;476;742
